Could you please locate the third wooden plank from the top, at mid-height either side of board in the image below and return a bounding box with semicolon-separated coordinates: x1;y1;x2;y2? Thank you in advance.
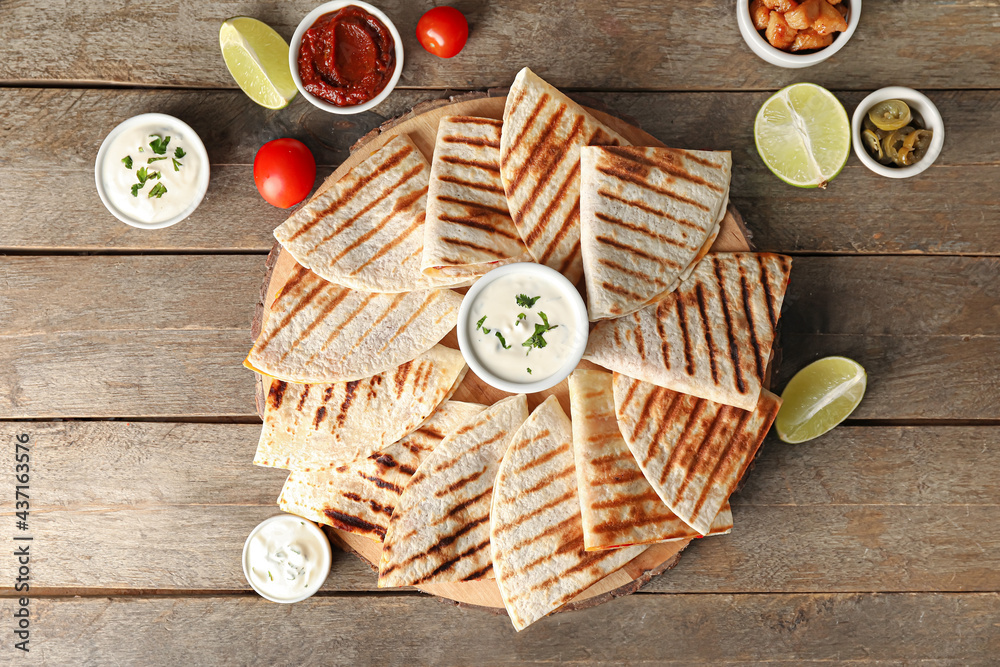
0;255;1000;419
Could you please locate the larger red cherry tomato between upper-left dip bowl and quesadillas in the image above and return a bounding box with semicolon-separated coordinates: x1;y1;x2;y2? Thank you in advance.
253;139;316;208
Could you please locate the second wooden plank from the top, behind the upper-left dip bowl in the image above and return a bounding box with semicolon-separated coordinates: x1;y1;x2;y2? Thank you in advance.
0;88;1000;254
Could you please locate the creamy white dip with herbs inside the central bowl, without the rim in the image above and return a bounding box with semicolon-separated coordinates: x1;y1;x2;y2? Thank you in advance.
467;273;587;383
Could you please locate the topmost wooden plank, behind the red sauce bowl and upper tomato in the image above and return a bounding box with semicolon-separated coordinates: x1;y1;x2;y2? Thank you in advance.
0;0;1000;90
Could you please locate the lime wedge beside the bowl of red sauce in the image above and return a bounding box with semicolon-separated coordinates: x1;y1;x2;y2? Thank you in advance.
219;16;298;109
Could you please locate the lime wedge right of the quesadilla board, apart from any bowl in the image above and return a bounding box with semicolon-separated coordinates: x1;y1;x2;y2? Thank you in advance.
774;357;868;445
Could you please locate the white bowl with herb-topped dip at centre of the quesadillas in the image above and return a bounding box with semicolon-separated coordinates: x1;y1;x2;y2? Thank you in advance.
458;262;590;394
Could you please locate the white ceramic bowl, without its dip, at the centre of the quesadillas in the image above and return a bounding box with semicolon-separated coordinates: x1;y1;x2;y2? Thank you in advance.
458;262;590;394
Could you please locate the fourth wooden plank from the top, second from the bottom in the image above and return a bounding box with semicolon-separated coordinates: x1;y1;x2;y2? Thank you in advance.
0;422;1000;594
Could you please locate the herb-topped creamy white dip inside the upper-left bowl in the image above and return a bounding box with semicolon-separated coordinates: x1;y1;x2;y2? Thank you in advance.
100;123;206;223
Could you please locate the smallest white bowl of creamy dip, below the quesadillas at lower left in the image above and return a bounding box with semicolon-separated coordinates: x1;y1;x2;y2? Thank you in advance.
243;514;333;604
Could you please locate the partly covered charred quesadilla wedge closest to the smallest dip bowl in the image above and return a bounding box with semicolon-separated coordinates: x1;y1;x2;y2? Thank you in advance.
278;401;486;542
